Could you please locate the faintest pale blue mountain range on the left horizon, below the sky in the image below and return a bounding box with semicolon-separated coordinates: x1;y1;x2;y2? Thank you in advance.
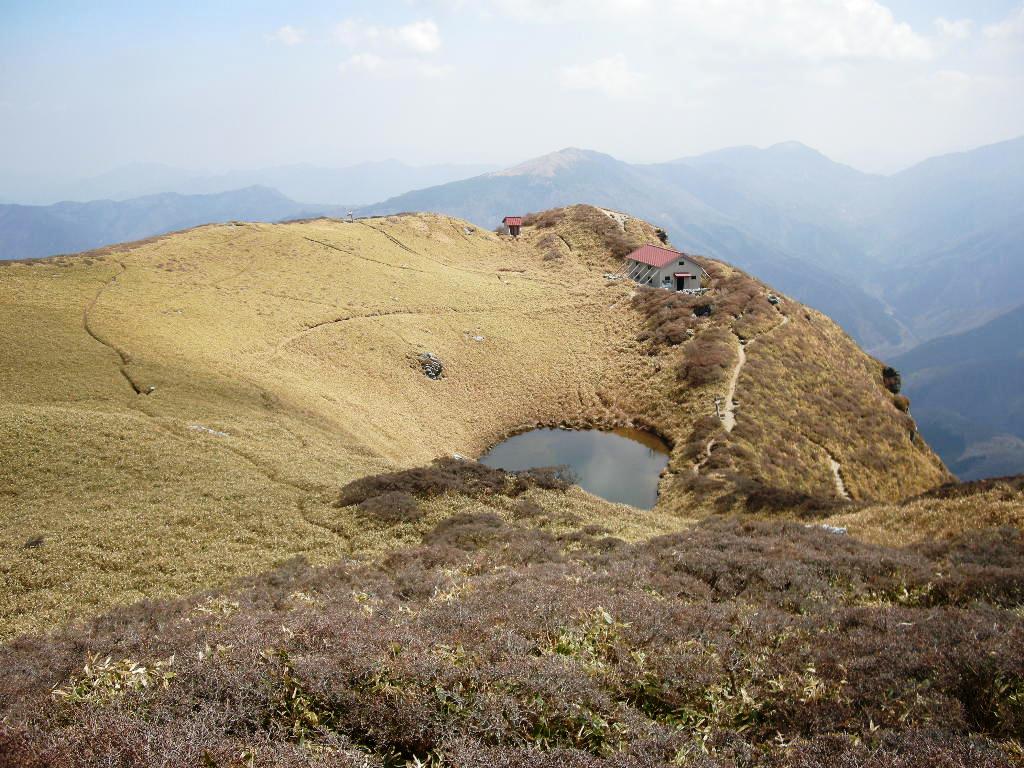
0;160;496;207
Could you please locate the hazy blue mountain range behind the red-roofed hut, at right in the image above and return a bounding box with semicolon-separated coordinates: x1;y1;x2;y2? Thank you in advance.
360;137;1024;353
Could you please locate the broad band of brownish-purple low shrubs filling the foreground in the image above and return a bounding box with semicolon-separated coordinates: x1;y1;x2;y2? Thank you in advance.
0;513;1024;768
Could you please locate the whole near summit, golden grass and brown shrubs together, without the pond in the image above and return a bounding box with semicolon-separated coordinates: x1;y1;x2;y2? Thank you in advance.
0;206;1024;766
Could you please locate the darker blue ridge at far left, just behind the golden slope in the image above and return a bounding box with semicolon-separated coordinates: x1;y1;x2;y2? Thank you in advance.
0;186;344;261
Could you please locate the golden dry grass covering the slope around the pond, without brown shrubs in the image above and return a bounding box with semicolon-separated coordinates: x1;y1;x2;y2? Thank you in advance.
0;208;945;636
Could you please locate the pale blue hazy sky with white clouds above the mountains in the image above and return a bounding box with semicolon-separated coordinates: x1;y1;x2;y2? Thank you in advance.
0;0;1024;183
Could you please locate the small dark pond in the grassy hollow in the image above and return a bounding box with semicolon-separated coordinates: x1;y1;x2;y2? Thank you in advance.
480;429;669;509
